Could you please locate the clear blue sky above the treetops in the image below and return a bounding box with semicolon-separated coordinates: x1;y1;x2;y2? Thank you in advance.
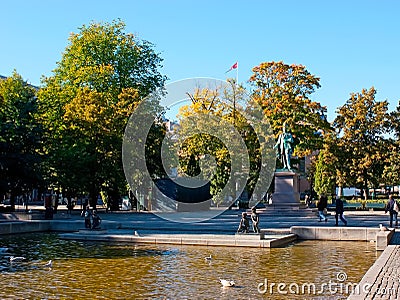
0;0;400;120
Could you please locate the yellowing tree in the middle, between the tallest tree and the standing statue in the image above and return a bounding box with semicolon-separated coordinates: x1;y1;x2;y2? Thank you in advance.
179;79;275;205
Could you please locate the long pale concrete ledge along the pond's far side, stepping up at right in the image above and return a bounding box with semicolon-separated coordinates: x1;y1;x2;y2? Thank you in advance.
60;226;394;250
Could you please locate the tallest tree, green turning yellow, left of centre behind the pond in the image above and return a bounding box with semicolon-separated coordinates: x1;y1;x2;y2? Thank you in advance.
38;20;166;206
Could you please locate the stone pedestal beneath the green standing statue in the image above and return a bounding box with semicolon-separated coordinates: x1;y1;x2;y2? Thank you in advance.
272;171;300;209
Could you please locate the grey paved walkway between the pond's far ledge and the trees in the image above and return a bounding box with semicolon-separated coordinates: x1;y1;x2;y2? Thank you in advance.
8;206;389;233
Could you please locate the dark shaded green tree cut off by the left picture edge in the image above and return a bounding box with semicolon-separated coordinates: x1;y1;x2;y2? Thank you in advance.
0;71;42;210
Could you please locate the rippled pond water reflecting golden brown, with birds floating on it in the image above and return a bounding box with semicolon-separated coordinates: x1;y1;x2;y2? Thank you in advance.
0;233;380;300
